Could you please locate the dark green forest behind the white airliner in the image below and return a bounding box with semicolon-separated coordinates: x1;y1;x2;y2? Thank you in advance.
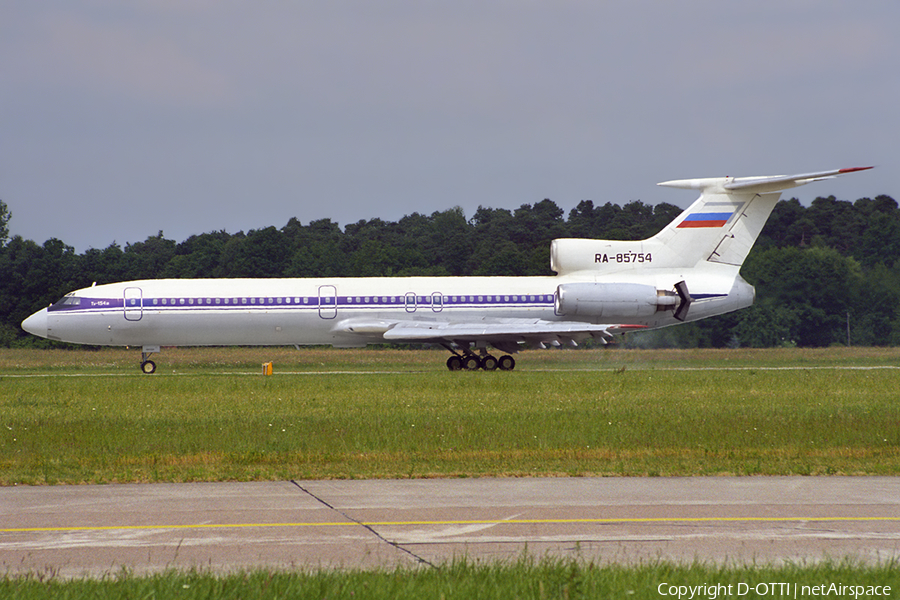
0;195;900;347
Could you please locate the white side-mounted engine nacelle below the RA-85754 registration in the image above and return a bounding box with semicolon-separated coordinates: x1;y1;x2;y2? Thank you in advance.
556;283;682;321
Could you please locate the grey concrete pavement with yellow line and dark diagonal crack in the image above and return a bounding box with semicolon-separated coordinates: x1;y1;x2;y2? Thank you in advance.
0;477;900;577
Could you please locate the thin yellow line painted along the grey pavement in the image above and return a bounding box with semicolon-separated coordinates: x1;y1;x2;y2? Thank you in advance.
7;517;900;533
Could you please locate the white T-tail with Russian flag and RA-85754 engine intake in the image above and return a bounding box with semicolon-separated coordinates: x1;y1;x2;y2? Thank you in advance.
550;167;872;275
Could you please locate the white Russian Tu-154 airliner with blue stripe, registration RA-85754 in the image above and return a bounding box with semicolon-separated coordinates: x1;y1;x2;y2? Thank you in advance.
22;167;872;374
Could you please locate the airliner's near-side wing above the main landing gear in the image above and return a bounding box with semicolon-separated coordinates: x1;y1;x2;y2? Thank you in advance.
343;319;646;352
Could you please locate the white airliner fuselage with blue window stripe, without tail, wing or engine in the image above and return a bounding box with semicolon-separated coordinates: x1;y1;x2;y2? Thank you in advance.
23;273;753;347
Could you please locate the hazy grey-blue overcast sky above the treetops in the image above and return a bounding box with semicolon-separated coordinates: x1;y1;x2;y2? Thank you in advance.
0;0;900;252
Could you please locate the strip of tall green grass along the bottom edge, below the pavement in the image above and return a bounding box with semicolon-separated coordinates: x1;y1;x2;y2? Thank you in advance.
0;557;900;600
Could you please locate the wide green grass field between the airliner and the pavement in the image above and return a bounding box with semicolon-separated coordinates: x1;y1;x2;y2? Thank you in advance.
0;348;900;485
